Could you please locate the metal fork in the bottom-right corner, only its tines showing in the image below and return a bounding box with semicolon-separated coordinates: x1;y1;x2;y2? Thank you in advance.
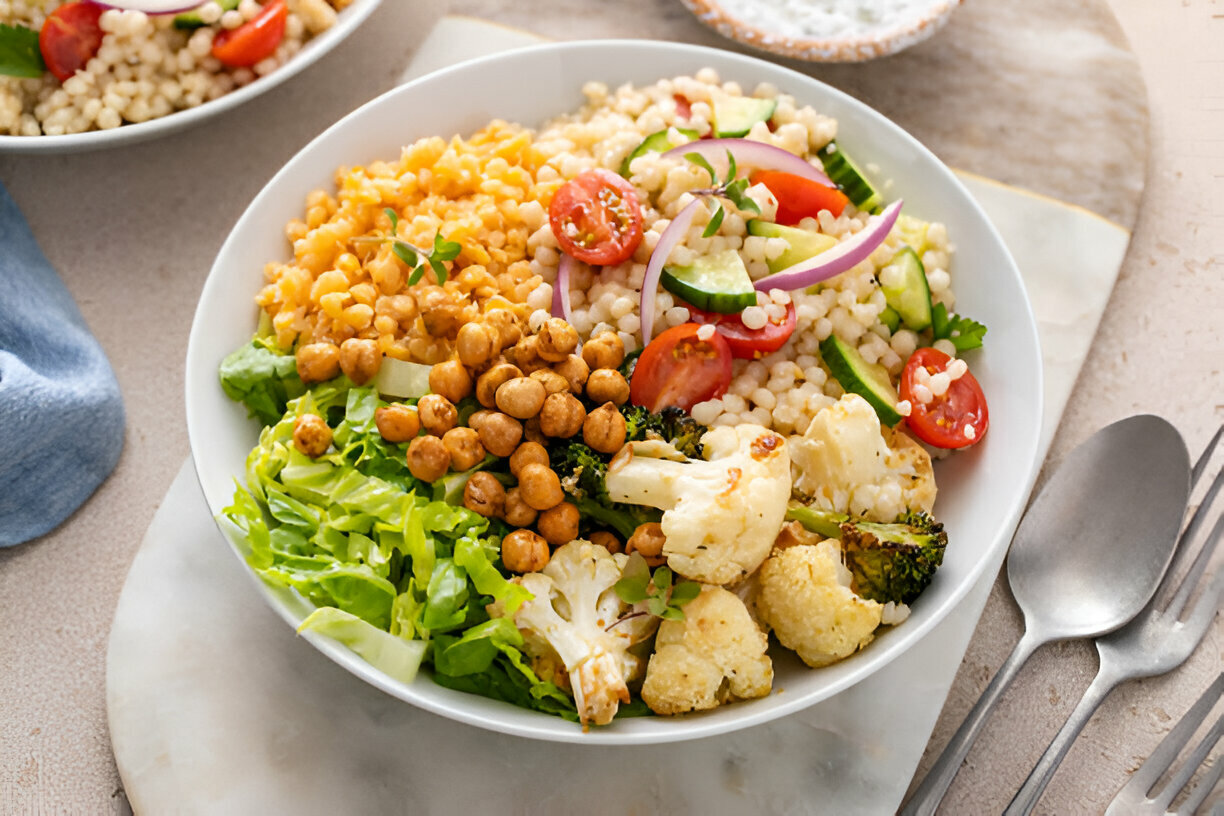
1105;674;1224;816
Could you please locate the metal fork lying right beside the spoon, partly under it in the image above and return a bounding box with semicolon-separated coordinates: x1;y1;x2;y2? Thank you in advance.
1004;426;1224;816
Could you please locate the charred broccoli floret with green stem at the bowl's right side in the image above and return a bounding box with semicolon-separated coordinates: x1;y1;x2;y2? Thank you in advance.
787;503;947;603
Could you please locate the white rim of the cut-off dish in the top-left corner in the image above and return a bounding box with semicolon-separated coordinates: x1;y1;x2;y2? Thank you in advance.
0;0;383;154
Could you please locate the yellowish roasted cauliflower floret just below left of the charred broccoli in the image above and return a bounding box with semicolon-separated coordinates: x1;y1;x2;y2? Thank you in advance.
756;522;884;668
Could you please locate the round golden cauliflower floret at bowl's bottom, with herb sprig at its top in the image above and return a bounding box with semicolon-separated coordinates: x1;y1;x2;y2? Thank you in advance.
641;586;774;714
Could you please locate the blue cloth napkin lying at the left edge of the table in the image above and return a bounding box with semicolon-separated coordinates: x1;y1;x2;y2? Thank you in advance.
0;185;124;547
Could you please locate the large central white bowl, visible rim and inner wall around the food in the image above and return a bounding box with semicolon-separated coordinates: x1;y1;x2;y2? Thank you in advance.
186;40;1042;744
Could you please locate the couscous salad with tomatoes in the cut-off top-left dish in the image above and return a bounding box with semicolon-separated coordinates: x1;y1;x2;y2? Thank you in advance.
0;0;351;136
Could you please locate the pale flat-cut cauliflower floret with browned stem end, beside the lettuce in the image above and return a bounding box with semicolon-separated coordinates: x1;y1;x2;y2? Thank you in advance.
514;540;657;725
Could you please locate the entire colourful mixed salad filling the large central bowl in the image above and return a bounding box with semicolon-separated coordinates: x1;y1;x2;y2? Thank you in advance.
220;70;989;727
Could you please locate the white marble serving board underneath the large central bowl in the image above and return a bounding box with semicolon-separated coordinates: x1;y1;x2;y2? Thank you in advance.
108;11;1129;814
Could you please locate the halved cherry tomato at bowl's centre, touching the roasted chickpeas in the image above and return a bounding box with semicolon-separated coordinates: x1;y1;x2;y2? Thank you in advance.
629;323;731;412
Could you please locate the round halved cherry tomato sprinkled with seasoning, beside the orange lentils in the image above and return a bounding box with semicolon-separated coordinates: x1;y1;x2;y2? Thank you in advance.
548;168;641;267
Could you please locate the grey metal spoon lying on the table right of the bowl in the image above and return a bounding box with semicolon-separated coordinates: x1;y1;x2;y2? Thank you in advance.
901;415;1190;816
